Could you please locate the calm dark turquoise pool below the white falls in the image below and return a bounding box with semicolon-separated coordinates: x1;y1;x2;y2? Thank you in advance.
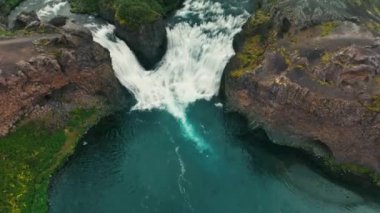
50;102;380;213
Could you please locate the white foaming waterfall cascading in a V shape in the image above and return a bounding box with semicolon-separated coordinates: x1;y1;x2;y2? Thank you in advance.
31;0;249;152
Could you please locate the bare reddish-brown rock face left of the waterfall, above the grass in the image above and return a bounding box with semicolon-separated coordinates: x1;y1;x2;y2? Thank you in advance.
0;17;125;136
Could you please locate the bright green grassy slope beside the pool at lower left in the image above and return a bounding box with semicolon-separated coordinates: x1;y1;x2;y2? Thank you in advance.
0;109;97;212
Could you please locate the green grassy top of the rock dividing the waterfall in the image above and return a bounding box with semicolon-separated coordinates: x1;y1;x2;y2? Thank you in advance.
70;0;180;27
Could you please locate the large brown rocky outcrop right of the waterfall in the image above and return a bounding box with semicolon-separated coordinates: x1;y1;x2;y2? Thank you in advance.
225;0;380;180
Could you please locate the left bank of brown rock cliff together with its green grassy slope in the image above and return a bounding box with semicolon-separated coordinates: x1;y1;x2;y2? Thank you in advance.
0;13;127;212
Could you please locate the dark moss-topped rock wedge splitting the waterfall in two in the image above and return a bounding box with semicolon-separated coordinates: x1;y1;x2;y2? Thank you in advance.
70;0;184;70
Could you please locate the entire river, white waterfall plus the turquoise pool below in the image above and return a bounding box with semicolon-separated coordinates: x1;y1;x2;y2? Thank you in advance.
10;0;380;213
